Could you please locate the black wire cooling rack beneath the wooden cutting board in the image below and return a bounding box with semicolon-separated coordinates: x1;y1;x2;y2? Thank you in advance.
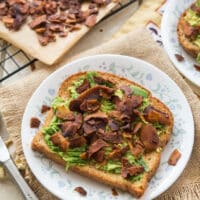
0;0;142;83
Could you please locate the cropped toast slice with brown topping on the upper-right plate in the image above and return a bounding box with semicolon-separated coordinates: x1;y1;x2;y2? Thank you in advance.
177;4;200;58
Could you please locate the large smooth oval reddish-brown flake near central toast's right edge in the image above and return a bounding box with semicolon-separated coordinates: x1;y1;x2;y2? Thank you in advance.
140;124;159;151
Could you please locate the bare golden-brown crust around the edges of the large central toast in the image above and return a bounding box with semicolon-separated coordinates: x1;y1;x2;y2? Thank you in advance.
32;72;173;197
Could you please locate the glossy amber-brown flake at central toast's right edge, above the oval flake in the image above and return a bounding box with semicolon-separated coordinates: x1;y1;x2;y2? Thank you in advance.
144;106;170;125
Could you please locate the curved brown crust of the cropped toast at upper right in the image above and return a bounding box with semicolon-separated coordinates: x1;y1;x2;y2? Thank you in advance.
177;9;200;58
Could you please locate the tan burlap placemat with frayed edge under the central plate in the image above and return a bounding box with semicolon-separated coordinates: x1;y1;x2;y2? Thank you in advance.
0;29;200;200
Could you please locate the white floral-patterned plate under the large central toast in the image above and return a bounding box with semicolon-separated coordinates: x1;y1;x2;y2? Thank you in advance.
21;55;194;200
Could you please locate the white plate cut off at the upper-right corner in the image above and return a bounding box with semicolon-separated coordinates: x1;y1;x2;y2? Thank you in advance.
161;0;200;87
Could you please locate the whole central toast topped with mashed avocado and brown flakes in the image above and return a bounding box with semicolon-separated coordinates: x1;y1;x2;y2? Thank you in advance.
32;72;173;197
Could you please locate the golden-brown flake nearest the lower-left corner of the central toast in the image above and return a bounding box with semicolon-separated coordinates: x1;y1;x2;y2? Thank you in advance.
50;132;69;151
